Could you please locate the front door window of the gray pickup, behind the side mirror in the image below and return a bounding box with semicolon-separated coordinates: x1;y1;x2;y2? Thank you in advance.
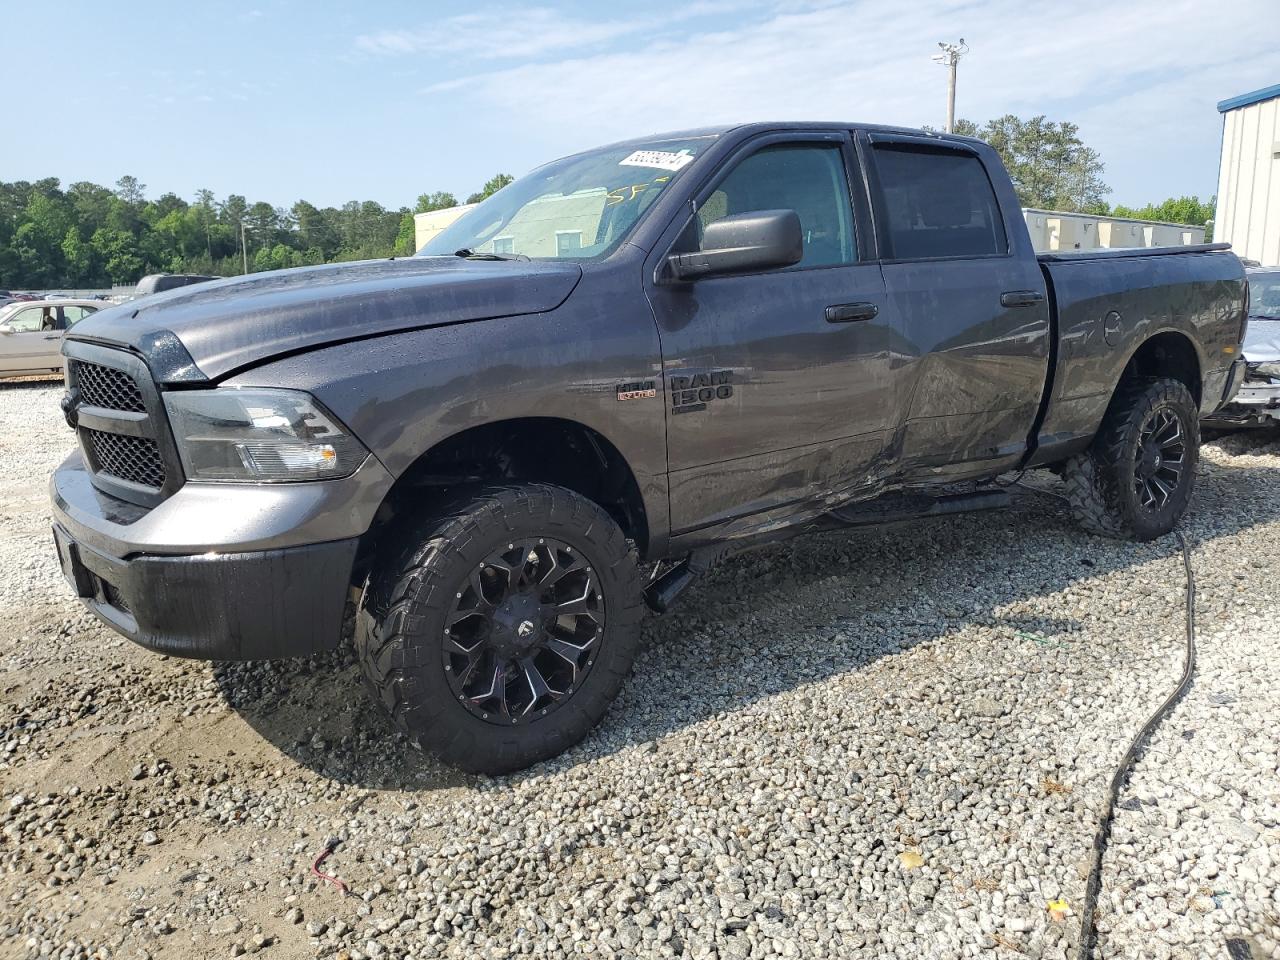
698;145;854;268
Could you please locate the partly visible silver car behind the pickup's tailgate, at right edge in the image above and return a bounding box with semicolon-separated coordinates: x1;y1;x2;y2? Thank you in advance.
1204;266;1280;429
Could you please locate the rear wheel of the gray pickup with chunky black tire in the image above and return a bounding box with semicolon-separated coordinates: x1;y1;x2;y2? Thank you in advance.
1062;379;1199;540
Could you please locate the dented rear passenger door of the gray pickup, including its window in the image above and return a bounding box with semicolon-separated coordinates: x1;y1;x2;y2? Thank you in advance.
860;133;1051;481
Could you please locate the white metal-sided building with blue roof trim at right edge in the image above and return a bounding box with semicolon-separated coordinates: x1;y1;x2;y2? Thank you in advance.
1213;83;1280;266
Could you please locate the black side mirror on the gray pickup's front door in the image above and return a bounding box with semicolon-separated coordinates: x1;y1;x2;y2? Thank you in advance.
667;210;804;280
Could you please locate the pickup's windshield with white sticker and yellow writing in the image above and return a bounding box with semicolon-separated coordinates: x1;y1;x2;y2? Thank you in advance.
417;137;712;260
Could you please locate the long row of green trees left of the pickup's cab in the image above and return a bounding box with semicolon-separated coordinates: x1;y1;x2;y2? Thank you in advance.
0;174;512;289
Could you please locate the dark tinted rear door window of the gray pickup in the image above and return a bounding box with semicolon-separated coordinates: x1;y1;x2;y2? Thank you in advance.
876;145;1009;260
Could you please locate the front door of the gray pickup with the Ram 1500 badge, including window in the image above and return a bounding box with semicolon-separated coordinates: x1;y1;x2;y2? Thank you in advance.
649;133;896;535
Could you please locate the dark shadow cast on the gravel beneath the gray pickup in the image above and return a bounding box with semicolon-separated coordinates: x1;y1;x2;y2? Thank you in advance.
214;434;1280;791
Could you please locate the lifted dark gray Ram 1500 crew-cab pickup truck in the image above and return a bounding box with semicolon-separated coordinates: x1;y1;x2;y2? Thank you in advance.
52;123;1245;773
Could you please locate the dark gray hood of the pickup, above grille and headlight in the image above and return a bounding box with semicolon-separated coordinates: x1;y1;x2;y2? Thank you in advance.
68;257;582;383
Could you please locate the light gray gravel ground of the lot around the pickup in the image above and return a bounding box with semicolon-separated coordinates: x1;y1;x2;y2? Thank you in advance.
0;384;1280;960
